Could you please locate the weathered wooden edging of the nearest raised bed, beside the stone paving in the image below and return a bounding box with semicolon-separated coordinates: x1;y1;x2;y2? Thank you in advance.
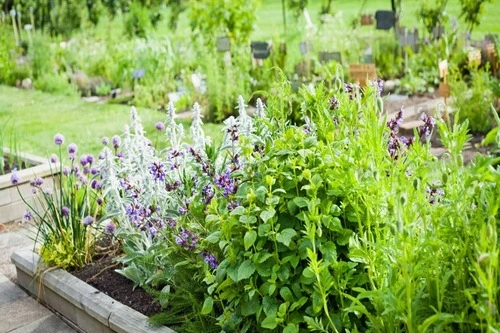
11;250;175;333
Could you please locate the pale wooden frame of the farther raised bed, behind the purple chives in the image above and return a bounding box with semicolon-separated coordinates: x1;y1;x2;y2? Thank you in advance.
0;149;55;224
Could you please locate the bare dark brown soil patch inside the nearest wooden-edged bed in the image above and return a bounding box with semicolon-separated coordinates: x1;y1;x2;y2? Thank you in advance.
70;256;161;317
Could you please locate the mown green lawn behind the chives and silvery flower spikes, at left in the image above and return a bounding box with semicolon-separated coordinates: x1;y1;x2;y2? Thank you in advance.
0;85;222;156
